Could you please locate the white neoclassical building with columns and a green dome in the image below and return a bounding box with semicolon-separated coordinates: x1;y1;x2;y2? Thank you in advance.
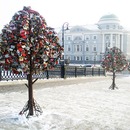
58;14;130;64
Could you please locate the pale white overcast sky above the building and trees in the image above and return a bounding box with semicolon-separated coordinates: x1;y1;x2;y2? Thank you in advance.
0;0;130;29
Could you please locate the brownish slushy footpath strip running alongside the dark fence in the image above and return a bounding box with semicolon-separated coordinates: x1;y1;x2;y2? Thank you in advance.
0;76;111;93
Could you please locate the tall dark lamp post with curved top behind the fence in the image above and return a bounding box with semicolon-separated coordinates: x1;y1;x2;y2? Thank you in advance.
61;22;69;78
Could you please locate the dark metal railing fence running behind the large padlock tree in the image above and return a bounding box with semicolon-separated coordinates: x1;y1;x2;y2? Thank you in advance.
0;66;106;81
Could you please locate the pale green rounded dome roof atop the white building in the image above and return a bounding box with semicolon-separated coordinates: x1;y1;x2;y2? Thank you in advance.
98;14;120;24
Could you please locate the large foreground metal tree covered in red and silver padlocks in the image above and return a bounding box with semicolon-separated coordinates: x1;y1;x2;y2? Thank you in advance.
0;7;63;117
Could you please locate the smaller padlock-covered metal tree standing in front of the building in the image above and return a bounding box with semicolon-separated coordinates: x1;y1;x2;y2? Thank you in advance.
101;47;128;90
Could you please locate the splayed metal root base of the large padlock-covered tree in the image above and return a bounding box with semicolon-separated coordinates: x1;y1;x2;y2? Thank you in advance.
19;100;43;118
